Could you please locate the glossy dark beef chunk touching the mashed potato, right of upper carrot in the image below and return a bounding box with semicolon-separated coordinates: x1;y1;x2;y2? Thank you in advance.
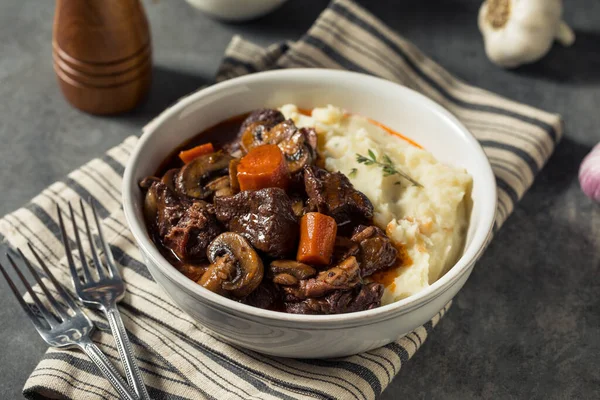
304;167;373;226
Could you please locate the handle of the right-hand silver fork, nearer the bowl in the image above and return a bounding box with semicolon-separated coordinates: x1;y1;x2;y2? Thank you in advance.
105;305;150;400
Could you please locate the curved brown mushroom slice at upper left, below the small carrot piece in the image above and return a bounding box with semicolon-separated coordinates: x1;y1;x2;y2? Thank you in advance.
175;152;232;199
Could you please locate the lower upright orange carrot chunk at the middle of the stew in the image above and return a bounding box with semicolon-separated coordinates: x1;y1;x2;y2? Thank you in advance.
296;212;337;265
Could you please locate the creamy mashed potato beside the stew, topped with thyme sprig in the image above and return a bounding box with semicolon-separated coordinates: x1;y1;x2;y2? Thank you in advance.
280;105;472;304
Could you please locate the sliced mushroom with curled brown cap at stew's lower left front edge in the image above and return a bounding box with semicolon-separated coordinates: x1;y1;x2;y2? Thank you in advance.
203;232;264;298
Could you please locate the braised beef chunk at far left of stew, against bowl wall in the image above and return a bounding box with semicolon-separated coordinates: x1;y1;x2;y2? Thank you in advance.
146;182;221;262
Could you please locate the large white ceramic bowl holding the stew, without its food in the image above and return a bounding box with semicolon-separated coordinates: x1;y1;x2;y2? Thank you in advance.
123;69;496;358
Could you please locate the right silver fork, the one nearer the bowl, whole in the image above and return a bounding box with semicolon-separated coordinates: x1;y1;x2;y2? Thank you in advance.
56;199;150;400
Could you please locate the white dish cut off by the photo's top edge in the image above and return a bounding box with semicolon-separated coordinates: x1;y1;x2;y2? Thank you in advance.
187;0;286;22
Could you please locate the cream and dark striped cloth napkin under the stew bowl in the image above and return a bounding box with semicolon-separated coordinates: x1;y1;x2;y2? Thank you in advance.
0;0;561;400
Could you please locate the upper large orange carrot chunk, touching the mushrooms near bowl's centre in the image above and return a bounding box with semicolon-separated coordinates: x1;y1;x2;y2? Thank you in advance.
237;144;290;190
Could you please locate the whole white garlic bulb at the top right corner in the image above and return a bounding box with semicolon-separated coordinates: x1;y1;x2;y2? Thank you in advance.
478;0;575;68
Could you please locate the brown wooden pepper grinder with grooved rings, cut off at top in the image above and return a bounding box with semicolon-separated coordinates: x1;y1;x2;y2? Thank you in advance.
52;0;152;114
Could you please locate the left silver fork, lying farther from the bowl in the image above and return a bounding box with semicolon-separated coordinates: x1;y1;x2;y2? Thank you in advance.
0;247;137;400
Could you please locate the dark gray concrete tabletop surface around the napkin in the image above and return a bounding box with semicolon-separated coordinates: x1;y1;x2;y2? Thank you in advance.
0;0;600;400
